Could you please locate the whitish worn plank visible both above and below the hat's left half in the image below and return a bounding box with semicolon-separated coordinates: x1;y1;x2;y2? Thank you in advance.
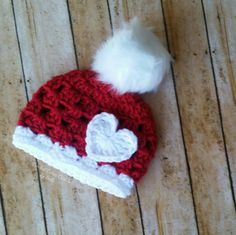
14;0;101;235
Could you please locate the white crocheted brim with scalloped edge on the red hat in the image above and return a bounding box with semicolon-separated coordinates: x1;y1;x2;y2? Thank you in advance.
13;126;134;198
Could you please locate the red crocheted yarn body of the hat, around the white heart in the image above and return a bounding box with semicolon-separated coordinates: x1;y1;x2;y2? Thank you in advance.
18;70;157;182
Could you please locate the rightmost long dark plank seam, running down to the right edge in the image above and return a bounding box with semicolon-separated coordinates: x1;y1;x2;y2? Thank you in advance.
201;0;236;211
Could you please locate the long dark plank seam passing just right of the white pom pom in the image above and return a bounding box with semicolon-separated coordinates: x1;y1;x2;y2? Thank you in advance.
160;0;199;234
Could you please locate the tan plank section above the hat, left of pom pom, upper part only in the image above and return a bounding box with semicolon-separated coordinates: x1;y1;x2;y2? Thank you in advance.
69;0;111;69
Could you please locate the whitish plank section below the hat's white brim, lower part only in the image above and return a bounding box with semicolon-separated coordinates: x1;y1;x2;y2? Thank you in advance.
40;171;102;235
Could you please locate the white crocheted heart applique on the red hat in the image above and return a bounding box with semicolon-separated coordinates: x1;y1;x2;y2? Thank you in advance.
85;112;138;162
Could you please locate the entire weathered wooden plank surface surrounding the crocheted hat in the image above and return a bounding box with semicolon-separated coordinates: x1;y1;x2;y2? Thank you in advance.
0;0;236;235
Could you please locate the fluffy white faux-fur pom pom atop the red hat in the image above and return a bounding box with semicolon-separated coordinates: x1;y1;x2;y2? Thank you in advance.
92;18;170;94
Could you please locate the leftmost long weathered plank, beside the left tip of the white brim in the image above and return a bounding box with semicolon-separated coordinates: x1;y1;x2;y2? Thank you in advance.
0;0;45;235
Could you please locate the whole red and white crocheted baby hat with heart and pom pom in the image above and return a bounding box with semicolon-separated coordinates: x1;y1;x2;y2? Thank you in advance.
13;20;169;198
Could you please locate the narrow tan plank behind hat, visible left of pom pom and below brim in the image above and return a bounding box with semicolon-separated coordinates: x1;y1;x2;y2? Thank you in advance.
69;0;143;234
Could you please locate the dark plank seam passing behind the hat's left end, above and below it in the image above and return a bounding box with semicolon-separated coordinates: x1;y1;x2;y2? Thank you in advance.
11;0;48;235
